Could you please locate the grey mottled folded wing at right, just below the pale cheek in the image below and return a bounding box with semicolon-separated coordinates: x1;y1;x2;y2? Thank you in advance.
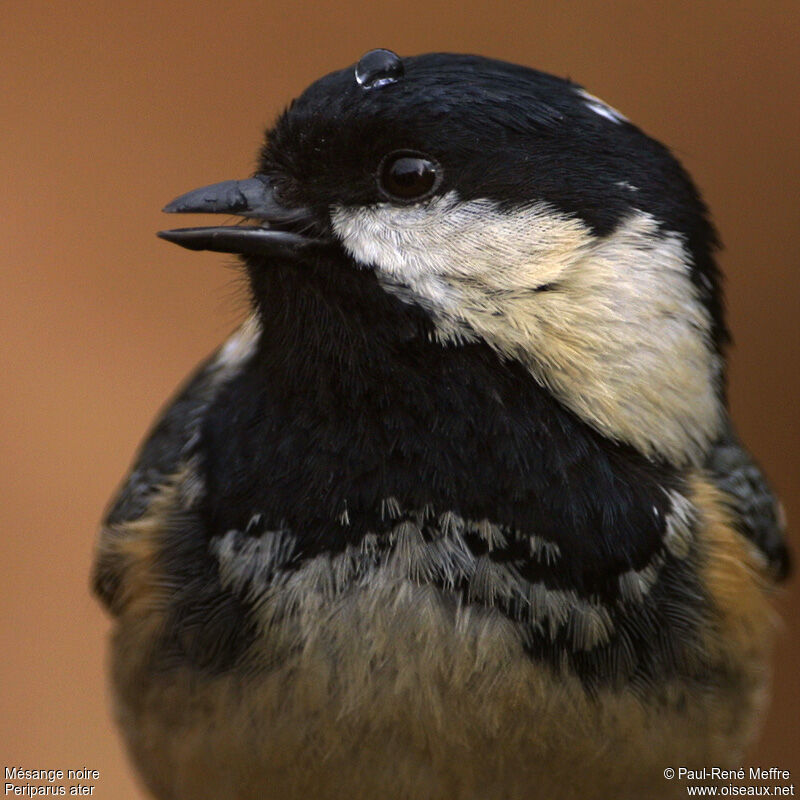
706;421;790;581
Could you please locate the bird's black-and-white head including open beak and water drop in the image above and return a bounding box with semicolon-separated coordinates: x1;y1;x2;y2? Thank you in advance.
162;50;726;463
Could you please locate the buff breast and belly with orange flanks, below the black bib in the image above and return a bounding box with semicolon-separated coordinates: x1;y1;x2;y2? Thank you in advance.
106;466;769;800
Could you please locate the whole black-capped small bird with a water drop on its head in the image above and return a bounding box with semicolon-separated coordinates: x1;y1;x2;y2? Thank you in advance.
93;50;788;800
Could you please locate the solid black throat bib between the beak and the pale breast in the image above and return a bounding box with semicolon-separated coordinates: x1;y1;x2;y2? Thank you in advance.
202;247;680;595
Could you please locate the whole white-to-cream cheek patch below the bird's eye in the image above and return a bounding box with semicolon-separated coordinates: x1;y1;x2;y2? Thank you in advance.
331;192;722;464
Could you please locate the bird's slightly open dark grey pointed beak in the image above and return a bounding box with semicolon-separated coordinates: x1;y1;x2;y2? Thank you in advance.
158;175;319;255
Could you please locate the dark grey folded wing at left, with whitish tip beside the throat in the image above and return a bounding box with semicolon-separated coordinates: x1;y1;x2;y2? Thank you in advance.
93;317;260;606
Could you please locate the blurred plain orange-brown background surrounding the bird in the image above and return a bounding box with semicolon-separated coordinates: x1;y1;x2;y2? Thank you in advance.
0;0;800;800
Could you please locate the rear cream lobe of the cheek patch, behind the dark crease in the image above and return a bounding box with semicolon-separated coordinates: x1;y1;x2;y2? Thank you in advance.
512;212;722;464
